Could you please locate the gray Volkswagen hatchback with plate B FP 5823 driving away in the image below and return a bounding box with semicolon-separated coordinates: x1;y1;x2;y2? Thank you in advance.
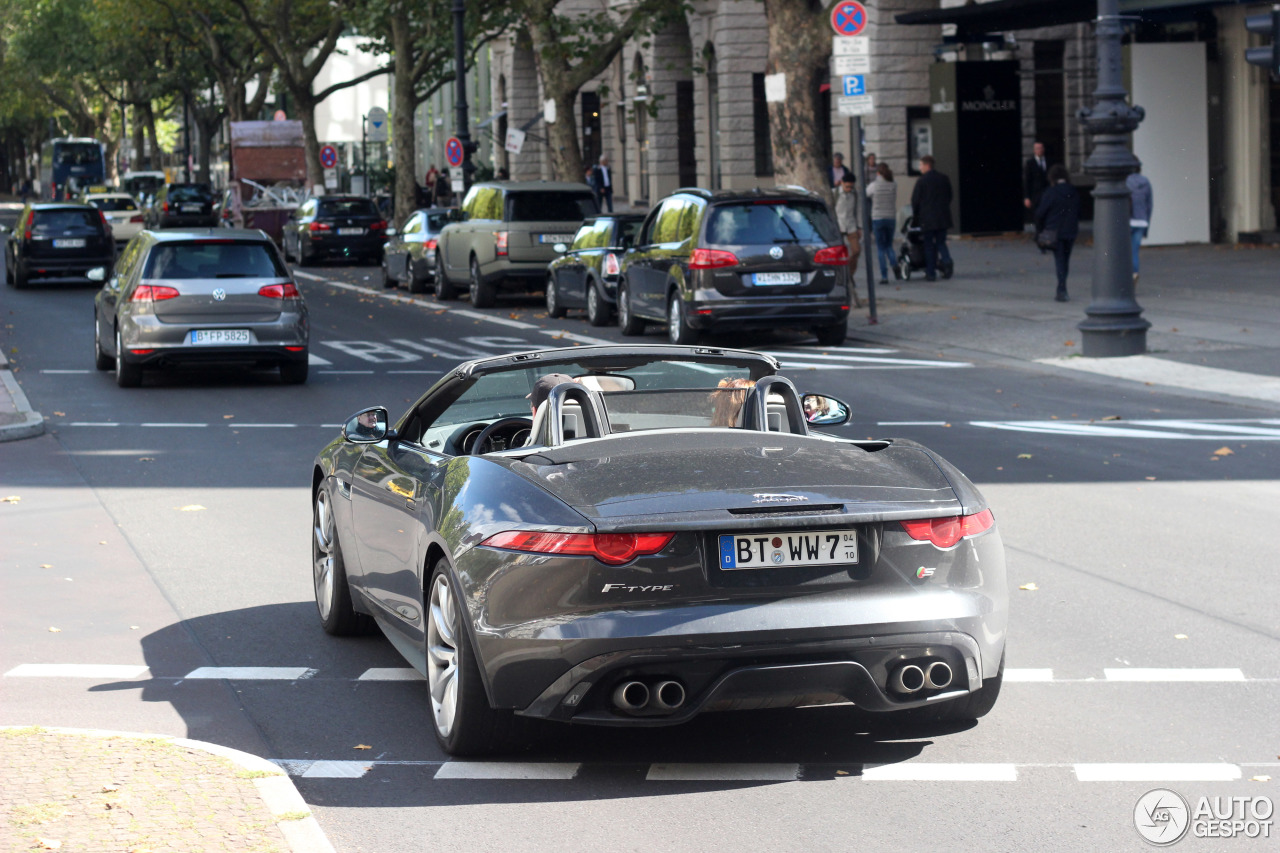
93;228;310;387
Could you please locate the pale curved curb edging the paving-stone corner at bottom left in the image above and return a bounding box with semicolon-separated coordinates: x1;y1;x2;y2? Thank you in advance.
0;726;337;853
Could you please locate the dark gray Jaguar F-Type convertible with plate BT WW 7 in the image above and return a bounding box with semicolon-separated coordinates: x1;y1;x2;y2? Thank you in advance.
311;346;1009;754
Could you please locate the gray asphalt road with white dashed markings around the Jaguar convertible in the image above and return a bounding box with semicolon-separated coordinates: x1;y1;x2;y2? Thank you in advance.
0;261;1280;852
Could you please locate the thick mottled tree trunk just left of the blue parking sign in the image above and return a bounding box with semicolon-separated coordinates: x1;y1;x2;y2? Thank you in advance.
764;0;834;204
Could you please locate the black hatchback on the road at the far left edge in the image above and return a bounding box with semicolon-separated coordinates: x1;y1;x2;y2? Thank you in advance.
4;202;115;287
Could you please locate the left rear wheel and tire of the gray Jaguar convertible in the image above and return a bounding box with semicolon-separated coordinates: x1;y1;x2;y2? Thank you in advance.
424;560;516;756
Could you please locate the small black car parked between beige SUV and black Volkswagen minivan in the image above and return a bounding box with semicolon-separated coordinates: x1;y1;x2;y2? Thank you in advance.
547;214;644;325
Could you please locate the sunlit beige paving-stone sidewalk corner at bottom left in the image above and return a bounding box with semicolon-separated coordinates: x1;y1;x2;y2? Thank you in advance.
0;727;333;853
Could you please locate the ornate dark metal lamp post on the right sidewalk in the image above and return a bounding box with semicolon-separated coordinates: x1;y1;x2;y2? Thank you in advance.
1076;0;1151;359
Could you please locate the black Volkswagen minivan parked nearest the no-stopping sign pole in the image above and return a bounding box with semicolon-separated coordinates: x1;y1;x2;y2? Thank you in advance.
618;190;852;346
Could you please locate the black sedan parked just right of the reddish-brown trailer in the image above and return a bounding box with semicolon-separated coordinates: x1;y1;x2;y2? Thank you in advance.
280;196;387;265
